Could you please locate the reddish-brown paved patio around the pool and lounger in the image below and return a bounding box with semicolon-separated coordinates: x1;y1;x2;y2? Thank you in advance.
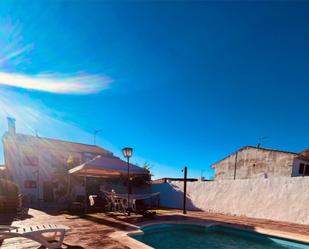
0;209;309;249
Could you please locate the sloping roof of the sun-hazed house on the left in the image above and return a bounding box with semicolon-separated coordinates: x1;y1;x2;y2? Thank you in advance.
3;133;113;155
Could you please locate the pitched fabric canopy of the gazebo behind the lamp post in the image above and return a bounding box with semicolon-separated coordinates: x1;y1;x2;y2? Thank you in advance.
69;156;149;177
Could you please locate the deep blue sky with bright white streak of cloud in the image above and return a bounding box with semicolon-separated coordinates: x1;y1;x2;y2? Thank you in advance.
0;1;309;178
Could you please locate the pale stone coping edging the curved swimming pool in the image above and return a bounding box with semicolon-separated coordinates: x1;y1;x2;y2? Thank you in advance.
110;220;309;249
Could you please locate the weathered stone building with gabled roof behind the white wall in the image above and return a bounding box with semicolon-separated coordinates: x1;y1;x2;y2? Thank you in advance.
212;146;309;180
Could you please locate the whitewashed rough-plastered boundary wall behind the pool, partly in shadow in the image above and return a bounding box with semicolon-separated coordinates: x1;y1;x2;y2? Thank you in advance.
152;177;309;224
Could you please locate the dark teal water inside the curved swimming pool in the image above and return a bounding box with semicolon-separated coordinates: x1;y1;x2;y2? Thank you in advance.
132;224;309;249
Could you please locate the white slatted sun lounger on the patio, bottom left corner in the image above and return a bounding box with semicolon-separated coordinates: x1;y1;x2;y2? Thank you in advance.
0;224;70;249
